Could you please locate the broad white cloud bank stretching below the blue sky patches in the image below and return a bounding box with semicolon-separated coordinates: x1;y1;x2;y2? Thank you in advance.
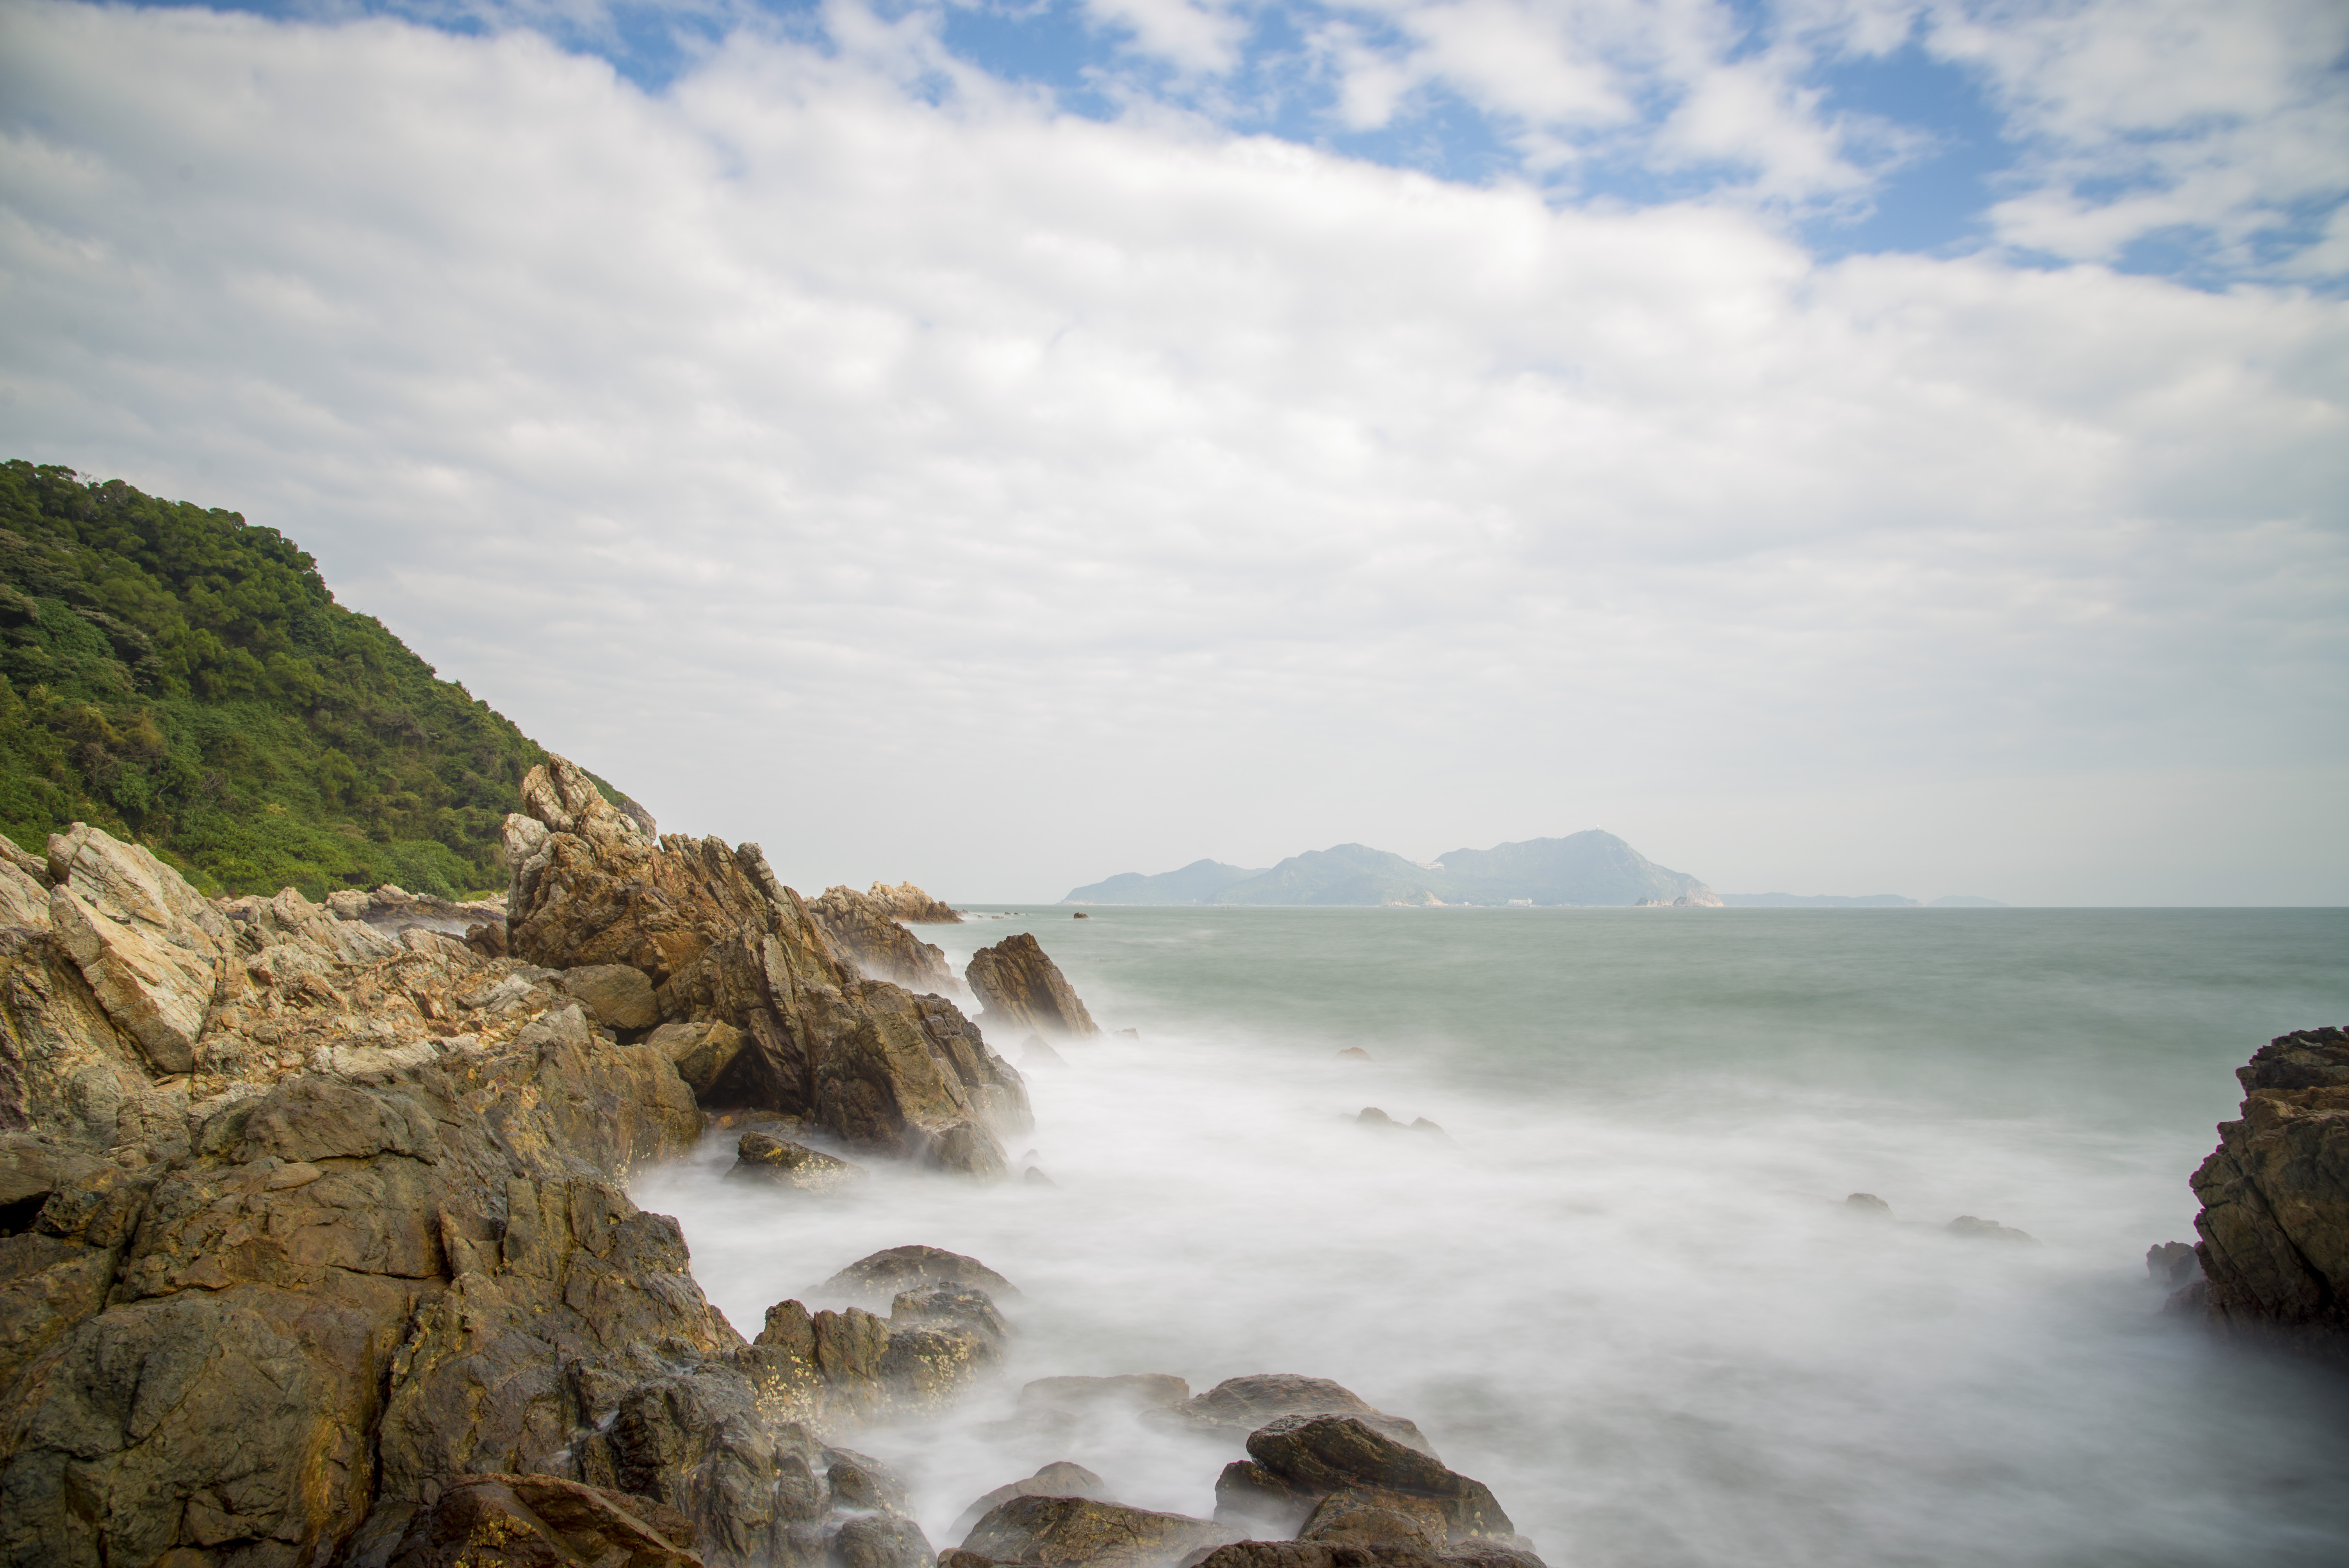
0;5;2349;897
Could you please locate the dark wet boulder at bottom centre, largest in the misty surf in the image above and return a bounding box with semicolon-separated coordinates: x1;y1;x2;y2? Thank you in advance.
1214;1415;1517;1545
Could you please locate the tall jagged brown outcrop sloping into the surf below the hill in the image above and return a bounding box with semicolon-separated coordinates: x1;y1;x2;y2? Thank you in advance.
505;756;1031;1176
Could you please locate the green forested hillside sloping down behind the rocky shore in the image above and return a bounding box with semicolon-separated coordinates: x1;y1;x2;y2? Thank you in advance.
0;462;545;899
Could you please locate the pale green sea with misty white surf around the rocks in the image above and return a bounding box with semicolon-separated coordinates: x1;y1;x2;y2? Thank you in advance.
636;909;2349;1568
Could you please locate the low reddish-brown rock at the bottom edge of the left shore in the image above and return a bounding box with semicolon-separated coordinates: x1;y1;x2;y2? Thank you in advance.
388;1477;702;1568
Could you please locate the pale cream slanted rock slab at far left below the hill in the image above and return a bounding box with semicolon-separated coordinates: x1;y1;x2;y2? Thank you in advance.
49;821;228;1073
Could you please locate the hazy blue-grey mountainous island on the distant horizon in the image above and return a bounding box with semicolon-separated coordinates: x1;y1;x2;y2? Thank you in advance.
1062;829;1720;906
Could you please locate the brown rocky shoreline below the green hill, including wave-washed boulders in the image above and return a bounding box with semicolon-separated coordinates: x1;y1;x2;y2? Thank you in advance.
0;758;1536;1568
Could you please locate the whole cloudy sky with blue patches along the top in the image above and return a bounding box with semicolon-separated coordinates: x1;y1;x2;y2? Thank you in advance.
0;0;2349;904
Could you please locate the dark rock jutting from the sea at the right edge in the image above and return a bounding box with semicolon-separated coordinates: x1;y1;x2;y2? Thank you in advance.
2187;1028;2349;1364
